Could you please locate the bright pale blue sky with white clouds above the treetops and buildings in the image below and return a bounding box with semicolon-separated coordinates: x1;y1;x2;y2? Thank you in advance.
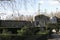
0;0;60;15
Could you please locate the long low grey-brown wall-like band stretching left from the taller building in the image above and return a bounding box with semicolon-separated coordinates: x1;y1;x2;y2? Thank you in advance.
0;20;32;28
